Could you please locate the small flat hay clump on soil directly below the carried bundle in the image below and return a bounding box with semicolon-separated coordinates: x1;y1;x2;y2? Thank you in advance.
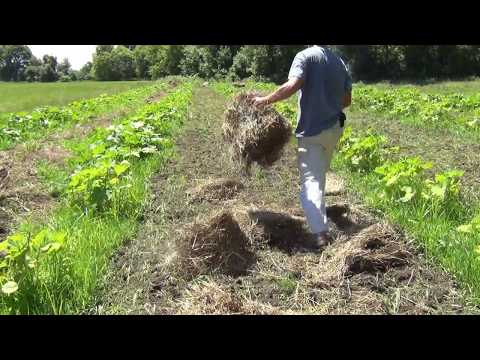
189;179;244;202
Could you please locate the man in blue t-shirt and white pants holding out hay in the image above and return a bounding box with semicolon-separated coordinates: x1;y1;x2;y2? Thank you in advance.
252;45;352;250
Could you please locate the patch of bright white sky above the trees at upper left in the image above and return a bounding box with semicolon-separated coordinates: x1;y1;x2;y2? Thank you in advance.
28;45;96;70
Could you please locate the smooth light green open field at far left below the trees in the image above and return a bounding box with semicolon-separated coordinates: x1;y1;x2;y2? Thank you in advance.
0;81;150;113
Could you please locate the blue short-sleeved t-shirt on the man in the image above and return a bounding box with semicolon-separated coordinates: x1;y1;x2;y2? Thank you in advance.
288;46;352;137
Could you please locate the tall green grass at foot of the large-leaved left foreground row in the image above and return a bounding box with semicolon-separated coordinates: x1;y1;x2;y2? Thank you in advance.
0;156;166;315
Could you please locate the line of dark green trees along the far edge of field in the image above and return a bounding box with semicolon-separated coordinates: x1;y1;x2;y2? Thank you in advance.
0;45;480;82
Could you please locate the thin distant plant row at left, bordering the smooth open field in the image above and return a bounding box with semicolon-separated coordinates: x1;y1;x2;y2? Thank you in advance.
0;83;171;149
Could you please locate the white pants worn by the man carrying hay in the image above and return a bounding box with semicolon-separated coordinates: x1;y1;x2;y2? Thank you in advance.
298;122;343;234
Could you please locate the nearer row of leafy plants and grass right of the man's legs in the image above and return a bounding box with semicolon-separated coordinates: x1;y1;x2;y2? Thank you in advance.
334;127;480;302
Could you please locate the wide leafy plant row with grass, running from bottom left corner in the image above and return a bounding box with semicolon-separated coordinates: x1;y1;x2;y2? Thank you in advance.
0;82;193;314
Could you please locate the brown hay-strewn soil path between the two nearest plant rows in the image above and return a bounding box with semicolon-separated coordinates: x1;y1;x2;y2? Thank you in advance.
91;87;478;314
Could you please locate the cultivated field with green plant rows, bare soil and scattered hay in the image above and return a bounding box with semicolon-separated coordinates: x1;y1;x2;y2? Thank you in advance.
0;78;480;314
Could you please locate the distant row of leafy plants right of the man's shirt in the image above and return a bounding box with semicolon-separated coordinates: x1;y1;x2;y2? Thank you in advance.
352;85;480;132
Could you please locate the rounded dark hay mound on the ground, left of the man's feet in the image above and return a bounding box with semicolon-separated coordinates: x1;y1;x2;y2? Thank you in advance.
177;211;254;277
